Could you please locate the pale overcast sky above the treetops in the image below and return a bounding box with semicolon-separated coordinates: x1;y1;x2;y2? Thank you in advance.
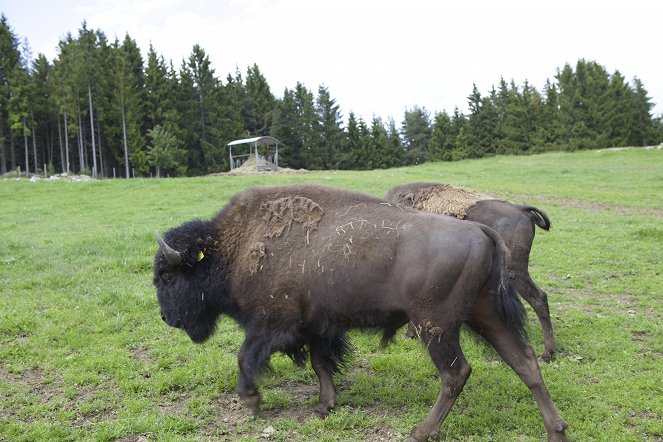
5;0;663;124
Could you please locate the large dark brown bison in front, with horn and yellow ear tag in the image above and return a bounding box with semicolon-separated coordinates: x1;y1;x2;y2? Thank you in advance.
154;185;566;441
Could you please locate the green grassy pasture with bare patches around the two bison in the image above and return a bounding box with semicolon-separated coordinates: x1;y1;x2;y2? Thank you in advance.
0;149;663;441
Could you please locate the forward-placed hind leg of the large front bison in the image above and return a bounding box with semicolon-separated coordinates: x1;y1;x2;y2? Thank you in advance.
408;325;472;442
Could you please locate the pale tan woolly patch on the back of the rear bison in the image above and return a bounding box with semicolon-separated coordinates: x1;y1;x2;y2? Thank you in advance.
398;184;495;219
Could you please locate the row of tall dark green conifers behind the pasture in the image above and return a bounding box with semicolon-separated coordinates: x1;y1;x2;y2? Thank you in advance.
0;14;663;177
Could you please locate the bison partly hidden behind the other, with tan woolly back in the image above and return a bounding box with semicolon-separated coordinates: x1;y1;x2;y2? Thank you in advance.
385;183;557;361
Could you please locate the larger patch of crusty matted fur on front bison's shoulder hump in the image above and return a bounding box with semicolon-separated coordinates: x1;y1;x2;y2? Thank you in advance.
260;196;324;243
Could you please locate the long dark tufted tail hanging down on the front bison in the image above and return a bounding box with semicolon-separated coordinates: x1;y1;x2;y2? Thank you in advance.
481;225;527;342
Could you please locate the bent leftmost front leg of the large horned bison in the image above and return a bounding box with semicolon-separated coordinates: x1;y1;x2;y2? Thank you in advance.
237;335;272;414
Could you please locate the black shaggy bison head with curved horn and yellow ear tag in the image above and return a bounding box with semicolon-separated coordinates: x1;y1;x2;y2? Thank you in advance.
154;220;224;343
